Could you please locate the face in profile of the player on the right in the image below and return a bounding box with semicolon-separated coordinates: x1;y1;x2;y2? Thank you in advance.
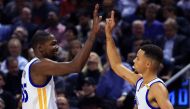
133;49;146;74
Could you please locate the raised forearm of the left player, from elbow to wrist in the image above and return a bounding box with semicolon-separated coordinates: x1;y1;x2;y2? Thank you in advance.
73;32;95;70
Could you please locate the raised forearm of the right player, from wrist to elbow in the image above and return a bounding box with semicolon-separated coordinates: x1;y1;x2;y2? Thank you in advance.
106;33;121;68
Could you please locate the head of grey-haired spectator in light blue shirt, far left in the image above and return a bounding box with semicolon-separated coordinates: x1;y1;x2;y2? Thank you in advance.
8;38;21;57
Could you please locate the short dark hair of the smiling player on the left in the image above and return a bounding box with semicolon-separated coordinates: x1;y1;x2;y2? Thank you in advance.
32;30;51;49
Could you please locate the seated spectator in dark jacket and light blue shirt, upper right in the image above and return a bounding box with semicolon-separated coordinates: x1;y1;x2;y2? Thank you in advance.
157;18;189;79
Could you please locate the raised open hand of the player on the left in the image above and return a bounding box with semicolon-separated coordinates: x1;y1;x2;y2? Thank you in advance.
92;4;102;34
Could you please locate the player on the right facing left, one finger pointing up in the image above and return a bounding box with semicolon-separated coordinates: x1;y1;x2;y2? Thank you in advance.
105;11;173;109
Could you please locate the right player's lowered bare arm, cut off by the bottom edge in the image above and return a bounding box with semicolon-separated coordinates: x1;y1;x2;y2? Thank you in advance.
150;83;173;109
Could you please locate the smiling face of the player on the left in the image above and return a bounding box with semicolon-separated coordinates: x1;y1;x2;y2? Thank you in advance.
43;35;58;59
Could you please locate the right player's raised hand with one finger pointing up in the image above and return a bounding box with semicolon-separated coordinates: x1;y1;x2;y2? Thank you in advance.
105;11;115;34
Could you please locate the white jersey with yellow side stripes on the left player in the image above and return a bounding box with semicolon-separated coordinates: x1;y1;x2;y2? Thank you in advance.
21;58;57;109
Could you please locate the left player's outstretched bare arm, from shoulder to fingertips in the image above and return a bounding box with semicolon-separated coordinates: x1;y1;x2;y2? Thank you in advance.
32;4;101;76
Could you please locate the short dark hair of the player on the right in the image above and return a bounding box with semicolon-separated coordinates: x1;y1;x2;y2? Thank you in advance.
140;44;163;63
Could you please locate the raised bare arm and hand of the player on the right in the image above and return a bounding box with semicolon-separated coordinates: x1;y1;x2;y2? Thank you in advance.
105;11;141;85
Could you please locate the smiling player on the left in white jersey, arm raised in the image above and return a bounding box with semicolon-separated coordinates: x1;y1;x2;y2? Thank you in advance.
22;4;101;109
